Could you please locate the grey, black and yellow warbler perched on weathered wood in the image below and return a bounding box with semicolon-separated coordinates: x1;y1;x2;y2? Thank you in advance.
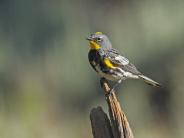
87;32;161;92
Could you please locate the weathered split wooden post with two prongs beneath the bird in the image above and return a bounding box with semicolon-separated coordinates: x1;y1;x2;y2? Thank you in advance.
90;79;134;138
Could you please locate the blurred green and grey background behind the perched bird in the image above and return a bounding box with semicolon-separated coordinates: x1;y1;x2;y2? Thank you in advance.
0;0;184;138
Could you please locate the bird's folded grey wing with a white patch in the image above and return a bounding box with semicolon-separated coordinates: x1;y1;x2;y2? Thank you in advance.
106;49;141;75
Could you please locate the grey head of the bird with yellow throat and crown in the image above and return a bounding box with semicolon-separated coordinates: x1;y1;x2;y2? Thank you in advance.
87;32;112;50
